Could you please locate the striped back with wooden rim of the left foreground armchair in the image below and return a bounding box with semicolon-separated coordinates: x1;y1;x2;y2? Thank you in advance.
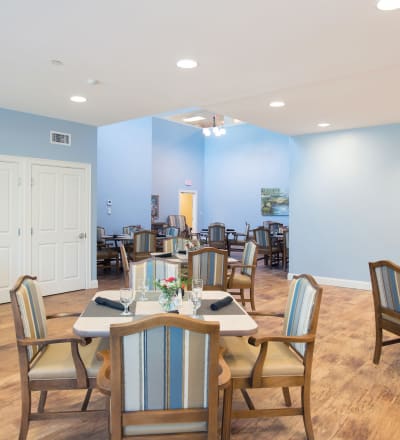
11;276;47;362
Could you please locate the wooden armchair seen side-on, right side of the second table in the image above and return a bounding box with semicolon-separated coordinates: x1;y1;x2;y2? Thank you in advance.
227;240;257;310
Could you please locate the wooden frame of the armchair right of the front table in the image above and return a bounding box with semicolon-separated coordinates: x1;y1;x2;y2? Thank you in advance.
224;275;322;440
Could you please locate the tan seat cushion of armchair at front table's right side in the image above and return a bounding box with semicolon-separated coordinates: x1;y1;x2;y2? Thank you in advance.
220;336;304;377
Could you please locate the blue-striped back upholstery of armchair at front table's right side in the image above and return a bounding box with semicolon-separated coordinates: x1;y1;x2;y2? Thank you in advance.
283;278;317;356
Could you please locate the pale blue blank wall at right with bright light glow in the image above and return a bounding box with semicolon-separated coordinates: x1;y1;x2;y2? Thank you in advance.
290;124;400;281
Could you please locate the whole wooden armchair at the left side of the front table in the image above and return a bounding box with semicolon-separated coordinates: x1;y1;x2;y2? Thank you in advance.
10;275;108;440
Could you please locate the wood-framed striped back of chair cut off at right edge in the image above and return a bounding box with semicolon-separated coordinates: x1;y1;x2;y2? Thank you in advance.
370;261;400;313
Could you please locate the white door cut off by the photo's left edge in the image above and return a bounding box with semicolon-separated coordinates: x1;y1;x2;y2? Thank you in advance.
0;160;21;303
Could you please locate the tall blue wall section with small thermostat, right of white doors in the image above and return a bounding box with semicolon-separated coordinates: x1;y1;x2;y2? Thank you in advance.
97;117;152;234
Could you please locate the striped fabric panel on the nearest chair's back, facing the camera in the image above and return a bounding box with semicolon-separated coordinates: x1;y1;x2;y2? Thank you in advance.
123;327;209;411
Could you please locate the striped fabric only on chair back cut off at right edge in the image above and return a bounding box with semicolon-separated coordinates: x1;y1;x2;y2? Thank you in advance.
375;266;400;313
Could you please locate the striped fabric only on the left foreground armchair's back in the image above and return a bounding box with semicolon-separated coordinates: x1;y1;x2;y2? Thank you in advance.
16;279;47;361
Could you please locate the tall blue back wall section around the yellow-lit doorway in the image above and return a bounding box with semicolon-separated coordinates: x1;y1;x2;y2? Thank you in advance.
152;118;204;224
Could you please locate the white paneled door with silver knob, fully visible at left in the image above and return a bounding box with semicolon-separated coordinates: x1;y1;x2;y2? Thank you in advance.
31;164;89;294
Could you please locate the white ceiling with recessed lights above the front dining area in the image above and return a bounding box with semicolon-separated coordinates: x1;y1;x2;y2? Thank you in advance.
0;0;400;134
